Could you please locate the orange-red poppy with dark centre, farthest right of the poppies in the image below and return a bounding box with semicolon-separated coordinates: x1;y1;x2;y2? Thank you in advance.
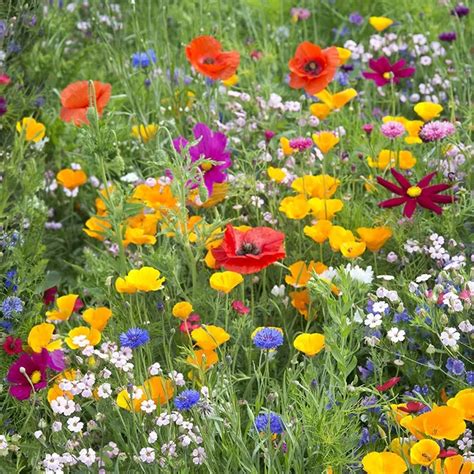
288;41;341;95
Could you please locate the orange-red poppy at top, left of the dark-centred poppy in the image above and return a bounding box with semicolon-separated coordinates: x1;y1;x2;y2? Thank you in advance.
186;36;240;81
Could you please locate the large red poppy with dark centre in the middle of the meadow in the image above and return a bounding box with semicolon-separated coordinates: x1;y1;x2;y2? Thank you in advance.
212;225;286;274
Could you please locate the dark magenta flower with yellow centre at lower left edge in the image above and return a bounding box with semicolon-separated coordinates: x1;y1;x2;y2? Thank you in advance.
7;349;65;400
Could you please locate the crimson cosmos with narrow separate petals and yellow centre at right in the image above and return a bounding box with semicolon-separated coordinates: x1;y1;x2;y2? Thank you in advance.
377;168;454;218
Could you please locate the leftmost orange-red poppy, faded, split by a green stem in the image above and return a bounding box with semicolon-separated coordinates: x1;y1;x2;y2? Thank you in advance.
59;81;112;125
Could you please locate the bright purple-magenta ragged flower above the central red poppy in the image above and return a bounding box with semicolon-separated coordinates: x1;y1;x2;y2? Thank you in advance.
173;123;232;194
